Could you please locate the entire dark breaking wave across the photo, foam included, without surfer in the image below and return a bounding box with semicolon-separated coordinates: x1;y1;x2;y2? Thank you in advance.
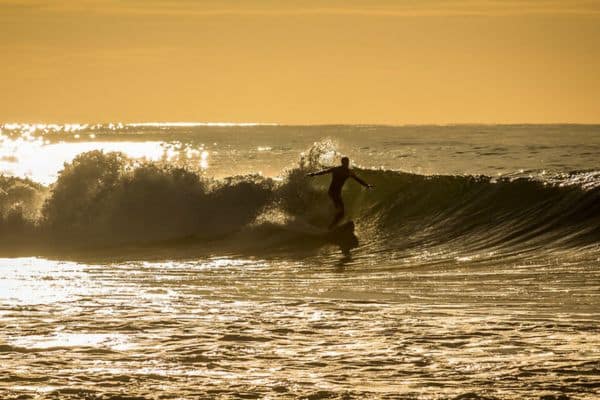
0;148;600;260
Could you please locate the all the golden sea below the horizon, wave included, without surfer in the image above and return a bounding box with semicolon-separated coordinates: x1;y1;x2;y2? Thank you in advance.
0;123;600;400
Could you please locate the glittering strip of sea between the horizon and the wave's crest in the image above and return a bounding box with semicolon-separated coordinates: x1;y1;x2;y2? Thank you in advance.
0;124;600;184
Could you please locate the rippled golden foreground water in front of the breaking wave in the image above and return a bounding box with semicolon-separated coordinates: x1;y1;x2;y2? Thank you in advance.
0;255;600;399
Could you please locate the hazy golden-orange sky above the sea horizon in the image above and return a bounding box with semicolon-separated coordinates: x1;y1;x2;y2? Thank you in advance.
0;0;600;124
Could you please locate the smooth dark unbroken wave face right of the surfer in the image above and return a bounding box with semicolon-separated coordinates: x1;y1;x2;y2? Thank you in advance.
352;171;600;250
